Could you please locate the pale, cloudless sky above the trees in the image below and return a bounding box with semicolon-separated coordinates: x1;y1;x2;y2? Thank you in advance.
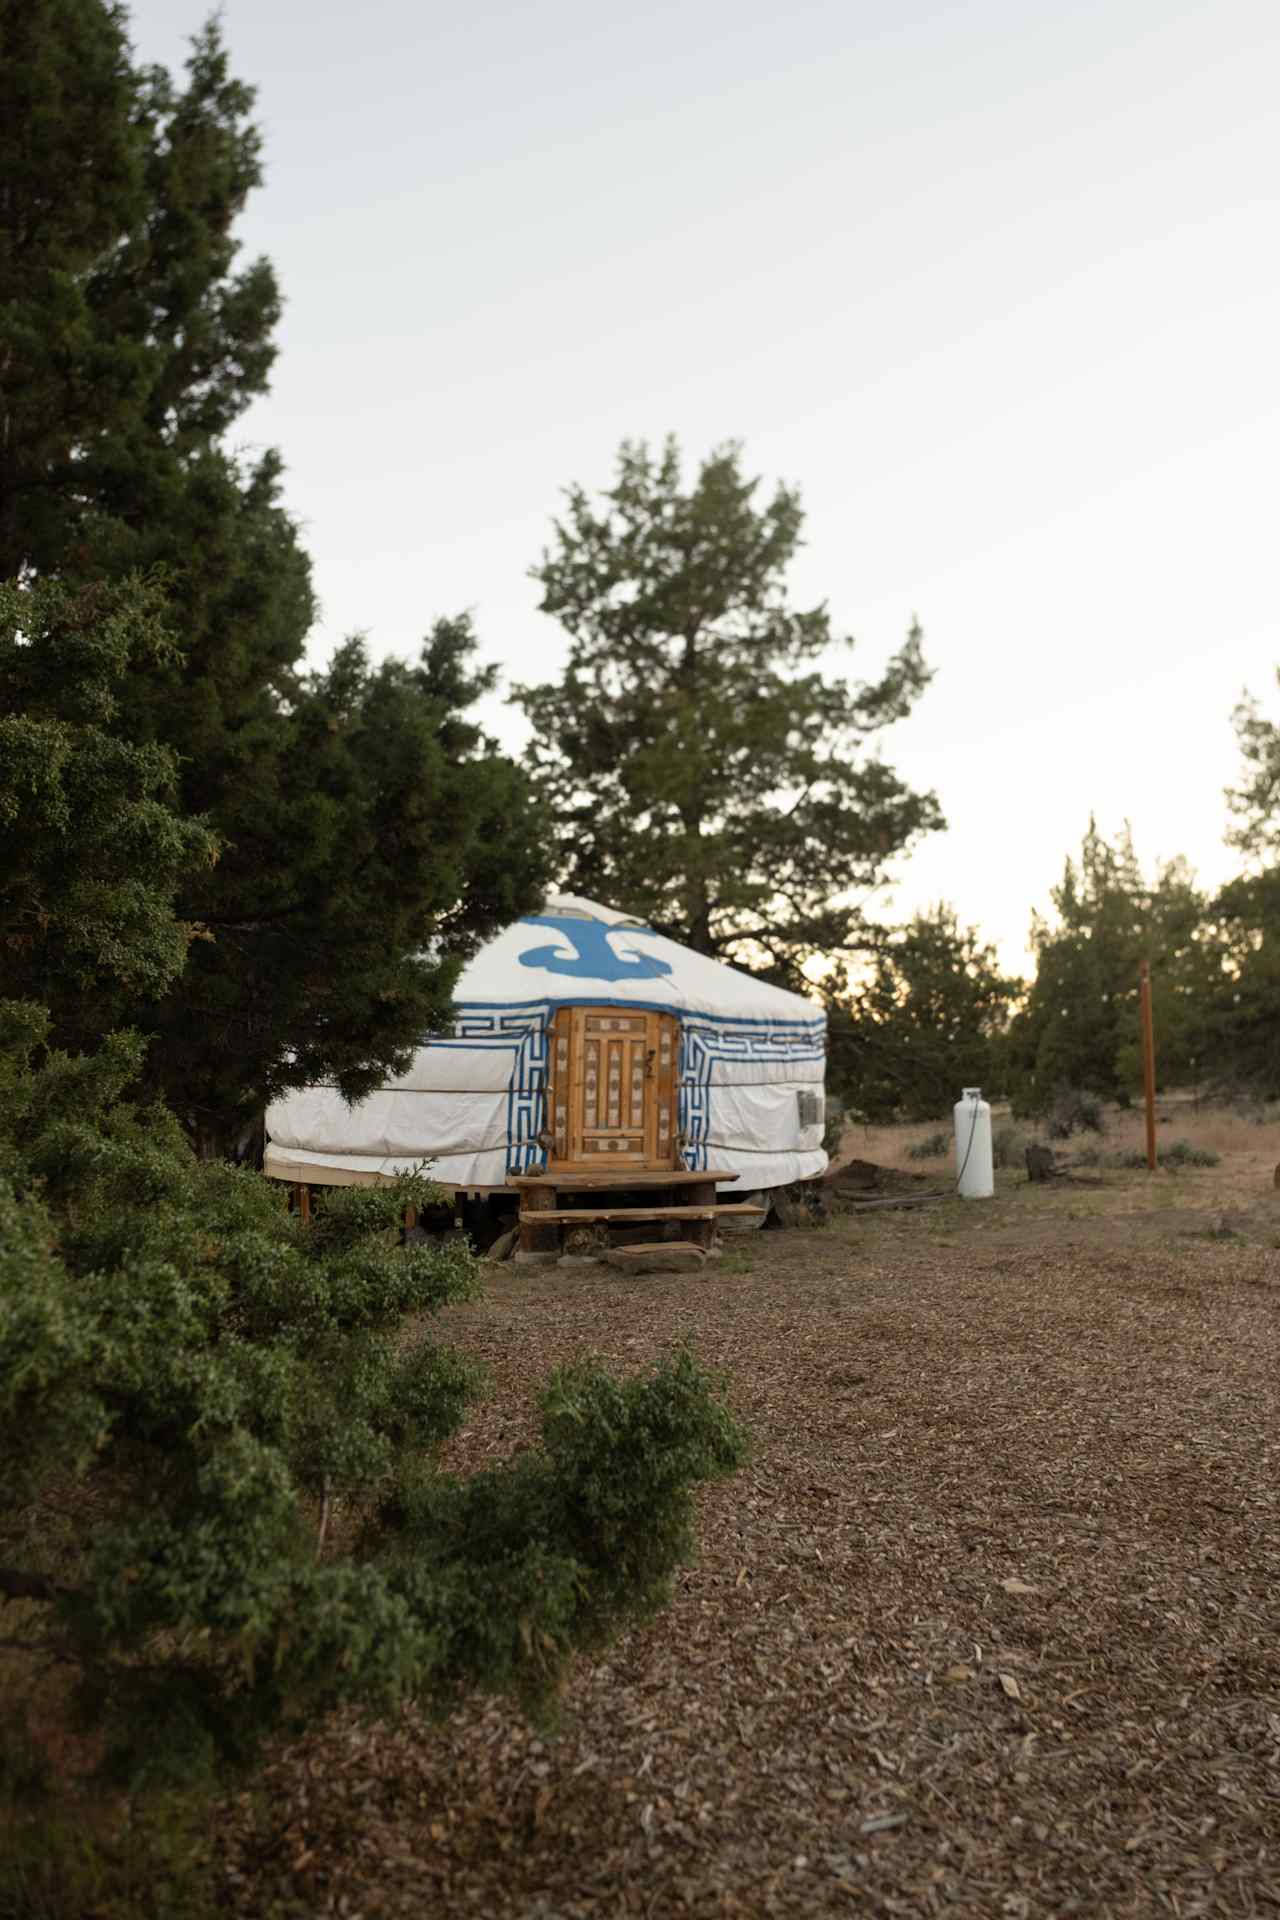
132;0;1280;966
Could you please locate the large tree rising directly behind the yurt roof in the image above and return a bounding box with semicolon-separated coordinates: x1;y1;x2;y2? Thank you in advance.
516;442;942;983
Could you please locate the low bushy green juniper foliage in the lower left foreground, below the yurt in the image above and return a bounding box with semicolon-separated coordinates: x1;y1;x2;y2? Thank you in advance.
0;1004;743;1789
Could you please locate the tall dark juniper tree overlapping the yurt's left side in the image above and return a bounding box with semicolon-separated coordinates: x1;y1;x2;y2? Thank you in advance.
0;0;547;1152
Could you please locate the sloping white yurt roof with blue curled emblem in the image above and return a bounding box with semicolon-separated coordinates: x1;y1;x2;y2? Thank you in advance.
455;893;825;1027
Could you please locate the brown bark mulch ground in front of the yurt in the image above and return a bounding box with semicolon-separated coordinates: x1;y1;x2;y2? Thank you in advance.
221;1198;1280;1920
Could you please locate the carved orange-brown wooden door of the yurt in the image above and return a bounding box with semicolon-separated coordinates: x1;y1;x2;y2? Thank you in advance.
549;1006;677;1171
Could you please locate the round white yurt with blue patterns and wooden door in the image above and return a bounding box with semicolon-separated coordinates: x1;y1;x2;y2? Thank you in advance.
265;895;827;1196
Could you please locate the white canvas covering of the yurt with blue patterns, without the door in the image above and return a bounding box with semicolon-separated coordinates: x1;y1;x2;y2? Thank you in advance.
267;897;827;1190
